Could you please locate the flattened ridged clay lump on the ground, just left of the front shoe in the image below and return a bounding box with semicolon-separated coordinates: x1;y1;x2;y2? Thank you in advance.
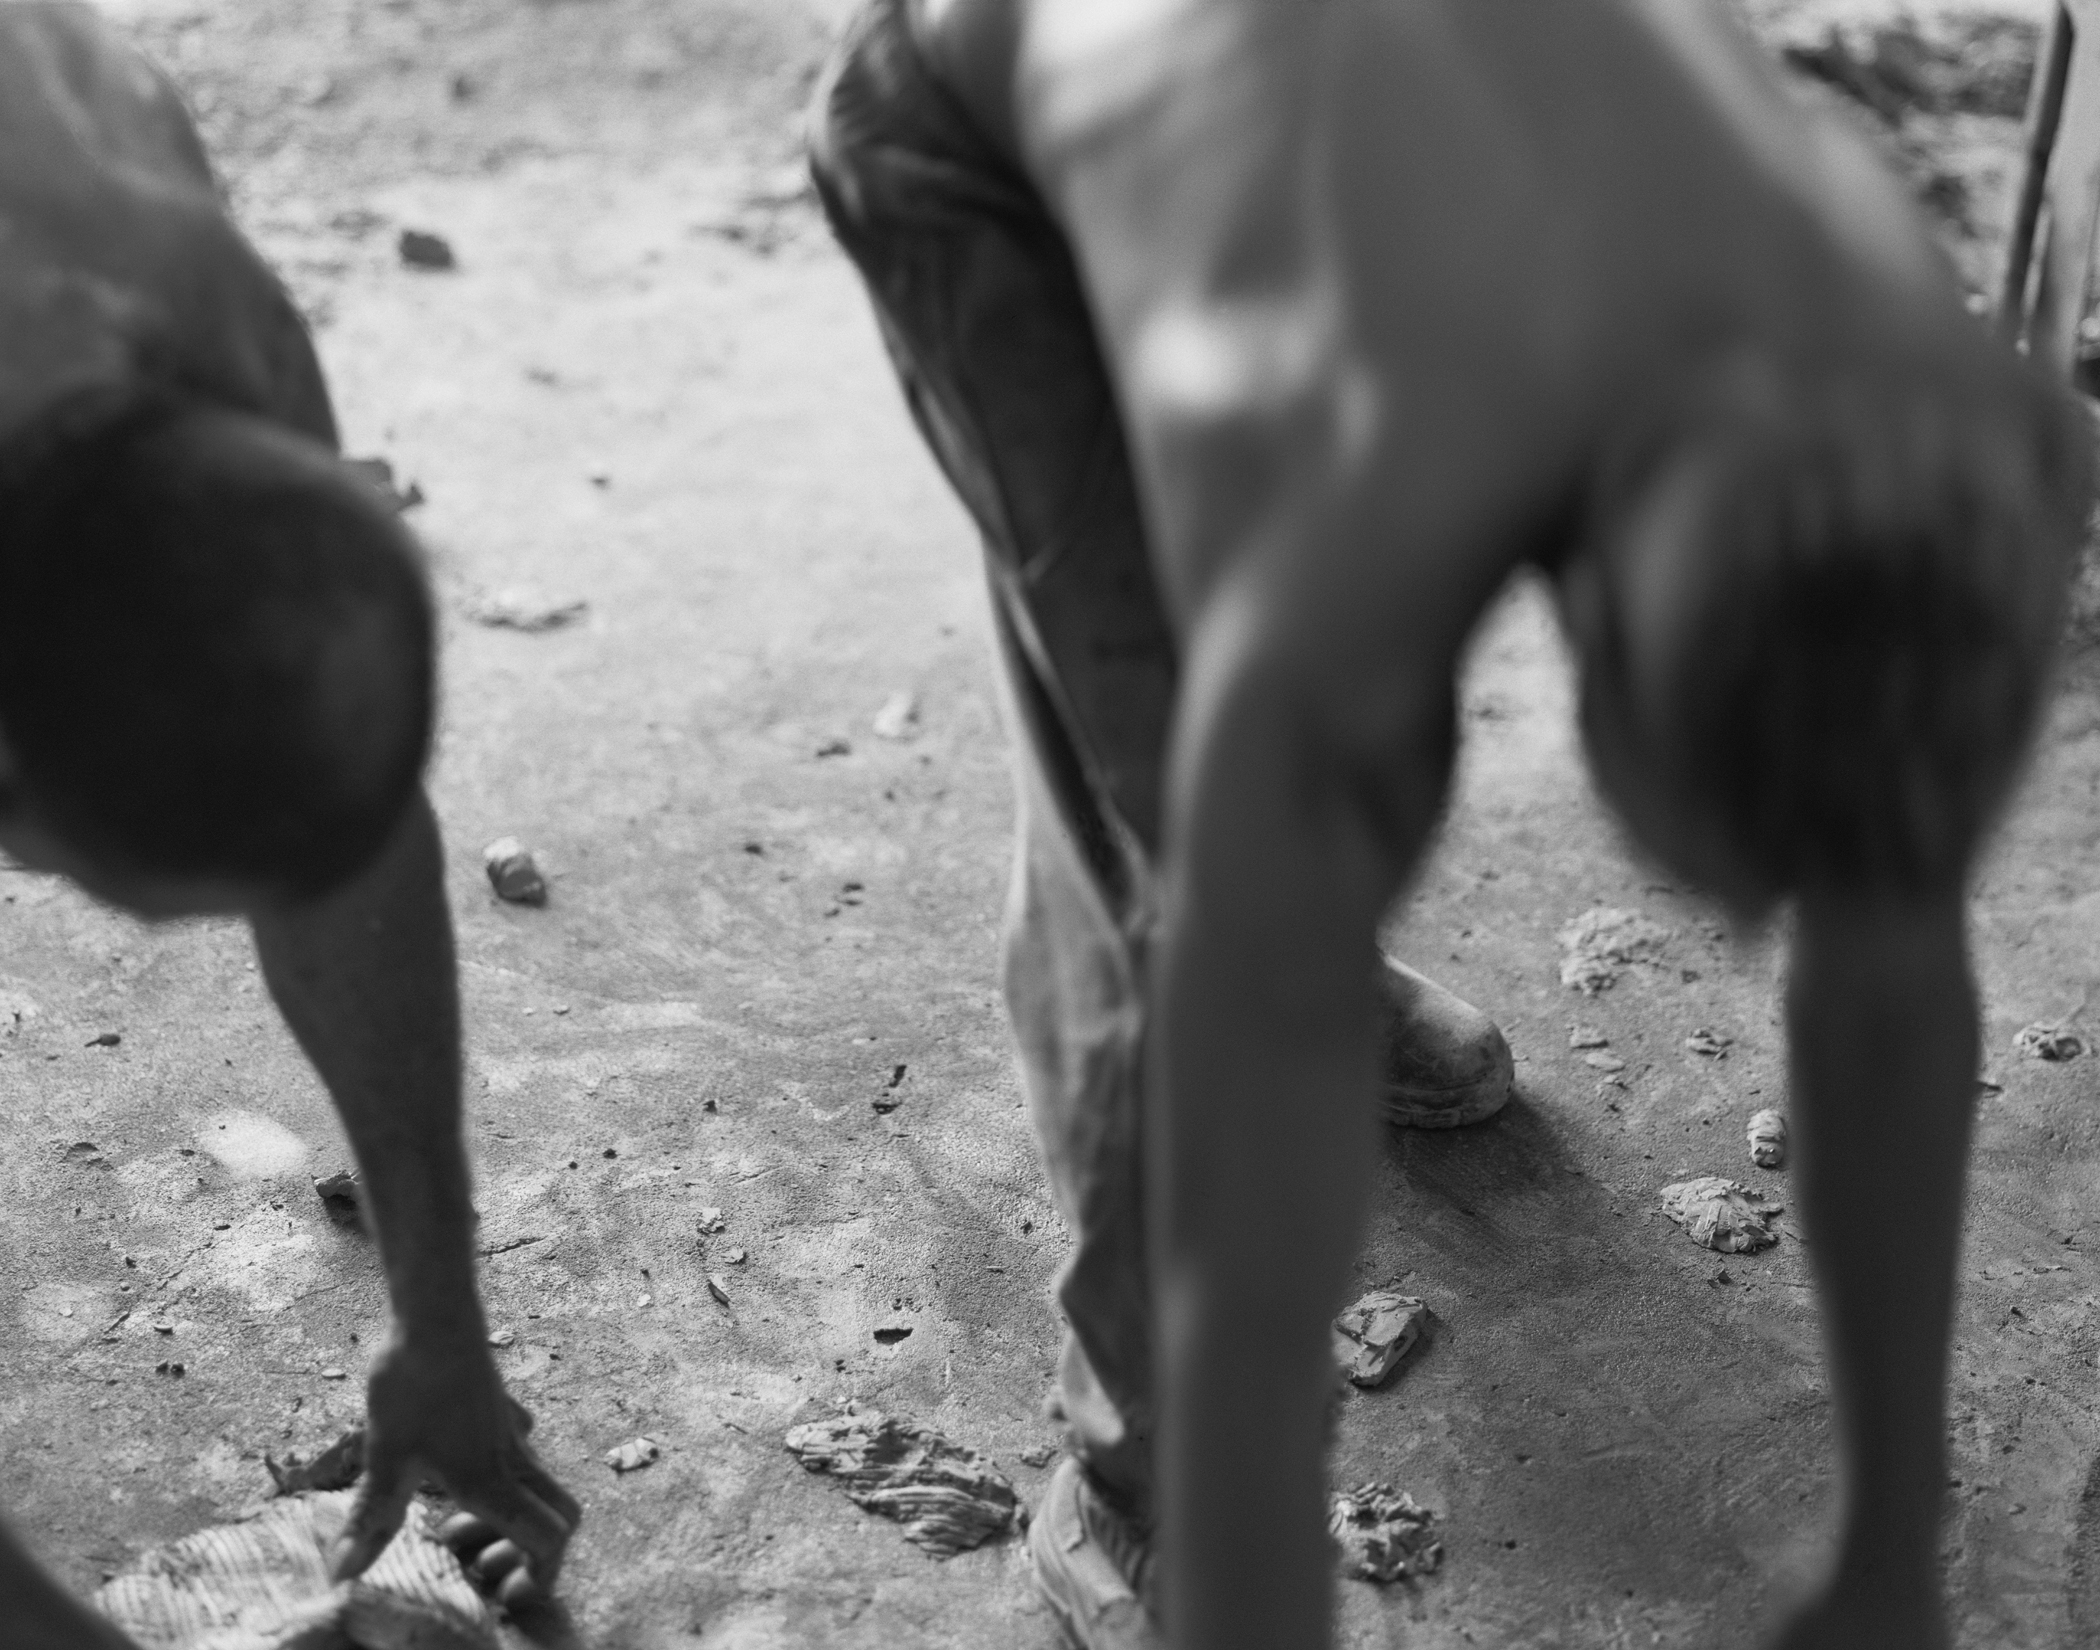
788;1411;1019;1558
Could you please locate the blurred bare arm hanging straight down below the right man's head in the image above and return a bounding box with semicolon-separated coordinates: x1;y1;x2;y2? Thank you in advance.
1777;894;1978;1650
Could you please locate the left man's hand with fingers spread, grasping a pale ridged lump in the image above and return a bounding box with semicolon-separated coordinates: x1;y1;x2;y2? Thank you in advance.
330;1333;582;1604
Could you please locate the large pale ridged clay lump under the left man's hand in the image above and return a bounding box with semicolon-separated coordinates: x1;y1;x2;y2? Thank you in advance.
95;1490;500;1650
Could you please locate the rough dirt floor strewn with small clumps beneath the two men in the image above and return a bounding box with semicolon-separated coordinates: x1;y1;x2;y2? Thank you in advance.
0;0;2100;1650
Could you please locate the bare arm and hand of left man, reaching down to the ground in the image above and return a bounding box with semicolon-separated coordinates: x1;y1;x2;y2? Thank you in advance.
254;796;578;1587
